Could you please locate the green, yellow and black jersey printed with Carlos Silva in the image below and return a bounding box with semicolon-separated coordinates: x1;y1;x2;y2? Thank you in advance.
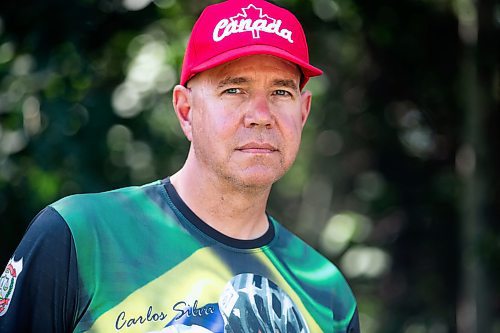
0;179;359;333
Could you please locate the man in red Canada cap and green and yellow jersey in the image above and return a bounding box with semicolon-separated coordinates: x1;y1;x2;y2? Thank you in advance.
0;0;359;333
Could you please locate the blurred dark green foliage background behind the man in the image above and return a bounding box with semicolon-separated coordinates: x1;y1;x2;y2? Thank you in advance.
0;0;500;333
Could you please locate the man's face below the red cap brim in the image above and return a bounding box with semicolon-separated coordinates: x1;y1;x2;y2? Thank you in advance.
184;55;311;187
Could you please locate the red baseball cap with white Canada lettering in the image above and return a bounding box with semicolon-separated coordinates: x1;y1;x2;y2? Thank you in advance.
180;0;323;89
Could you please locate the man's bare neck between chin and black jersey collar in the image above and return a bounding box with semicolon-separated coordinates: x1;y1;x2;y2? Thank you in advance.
170;166;271;240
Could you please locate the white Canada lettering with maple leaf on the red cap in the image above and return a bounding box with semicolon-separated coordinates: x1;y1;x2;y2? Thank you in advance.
212;5;293;43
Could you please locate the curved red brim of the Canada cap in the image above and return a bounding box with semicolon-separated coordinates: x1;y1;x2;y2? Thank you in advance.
184;44;323;88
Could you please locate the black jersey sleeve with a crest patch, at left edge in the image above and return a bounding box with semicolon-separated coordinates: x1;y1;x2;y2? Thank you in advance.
0;207;79;333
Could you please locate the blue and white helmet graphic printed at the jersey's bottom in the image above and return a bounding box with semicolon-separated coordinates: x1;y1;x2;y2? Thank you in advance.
160;273;309;333
